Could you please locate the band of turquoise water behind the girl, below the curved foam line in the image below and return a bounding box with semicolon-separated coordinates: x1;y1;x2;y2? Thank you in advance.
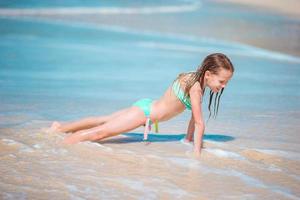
0;19;300;118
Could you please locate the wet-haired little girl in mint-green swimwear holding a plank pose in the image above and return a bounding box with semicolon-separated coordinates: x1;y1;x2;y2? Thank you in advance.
51;53;234;155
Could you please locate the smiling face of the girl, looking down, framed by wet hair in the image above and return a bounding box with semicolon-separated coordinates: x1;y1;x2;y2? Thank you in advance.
204;68;232;93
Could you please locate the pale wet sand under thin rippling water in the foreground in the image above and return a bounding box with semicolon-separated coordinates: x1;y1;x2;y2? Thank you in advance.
0;121;299;199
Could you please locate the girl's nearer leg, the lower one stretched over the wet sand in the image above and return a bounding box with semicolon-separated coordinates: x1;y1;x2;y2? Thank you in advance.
64;107;146;144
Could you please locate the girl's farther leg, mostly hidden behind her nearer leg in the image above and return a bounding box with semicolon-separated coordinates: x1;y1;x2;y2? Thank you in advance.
51;108;128;133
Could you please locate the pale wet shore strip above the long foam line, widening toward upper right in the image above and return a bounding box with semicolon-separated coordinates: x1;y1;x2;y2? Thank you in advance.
0;0;300;57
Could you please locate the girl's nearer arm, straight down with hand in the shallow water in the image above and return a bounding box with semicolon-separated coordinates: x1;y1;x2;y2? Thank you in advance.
189;82;205;155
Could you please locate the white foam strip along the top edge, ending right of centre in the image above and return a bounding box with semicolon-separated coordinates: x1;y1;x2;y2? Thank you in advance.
0;2;201;16
